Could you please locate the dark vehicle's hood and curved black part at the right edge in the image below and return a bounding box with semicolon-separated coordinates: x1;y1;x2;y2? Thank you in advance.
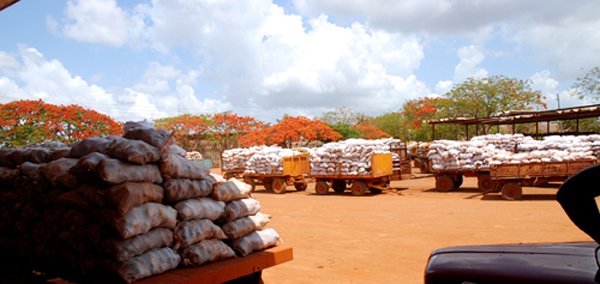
425;165;600;284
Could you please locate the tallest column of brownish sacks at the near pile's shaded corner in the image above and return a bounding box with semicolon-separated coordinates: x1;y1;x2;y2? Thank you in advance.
71;123;180;282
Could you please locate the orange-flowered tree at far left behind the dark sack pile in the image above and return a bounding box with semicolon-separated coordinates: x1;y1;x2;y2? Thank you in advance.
0;100;123;147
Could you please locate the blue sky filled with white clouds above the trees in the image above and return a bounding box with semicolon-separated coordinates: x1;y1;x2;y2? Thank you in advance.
0;0;600;122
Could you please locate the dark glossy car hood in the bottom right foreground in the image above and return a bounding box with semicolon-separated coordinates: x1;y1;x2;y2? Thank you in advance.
425;242;598;283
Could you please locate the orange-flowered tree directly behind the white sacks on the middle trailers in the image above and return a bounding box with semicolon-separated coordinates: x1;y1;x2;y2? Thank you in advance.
240;116;342;147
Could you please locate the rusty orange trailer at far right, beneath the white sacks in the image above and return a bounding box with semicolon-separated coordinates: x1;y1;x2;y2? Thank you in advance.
490;160;596;200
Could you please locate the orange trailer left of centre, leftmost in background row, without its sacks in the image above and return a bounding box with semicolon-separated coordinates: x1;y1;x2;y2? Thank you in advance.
223;156;310;194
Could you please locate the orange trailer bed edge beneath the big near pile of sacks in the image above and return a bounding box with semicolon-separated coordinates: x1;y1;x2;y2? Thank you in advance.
136;246;293;284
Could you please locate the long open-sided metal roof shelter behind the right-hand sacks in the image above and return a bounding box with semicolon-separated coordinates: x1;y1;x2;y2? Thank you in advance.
428;104;600;139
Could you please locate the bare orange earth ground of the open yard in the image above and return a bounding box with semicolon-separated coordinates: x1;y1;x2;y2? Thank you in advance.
218;169;591;283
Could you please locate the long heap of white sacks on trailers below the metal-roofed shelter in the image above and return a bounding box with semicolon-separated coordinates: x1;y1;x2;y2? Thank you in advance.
427;134;600;170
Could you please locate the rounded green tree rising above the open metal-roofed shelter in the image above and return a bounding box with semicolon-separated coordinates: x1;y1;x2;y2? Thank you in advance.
444;76;546;134
